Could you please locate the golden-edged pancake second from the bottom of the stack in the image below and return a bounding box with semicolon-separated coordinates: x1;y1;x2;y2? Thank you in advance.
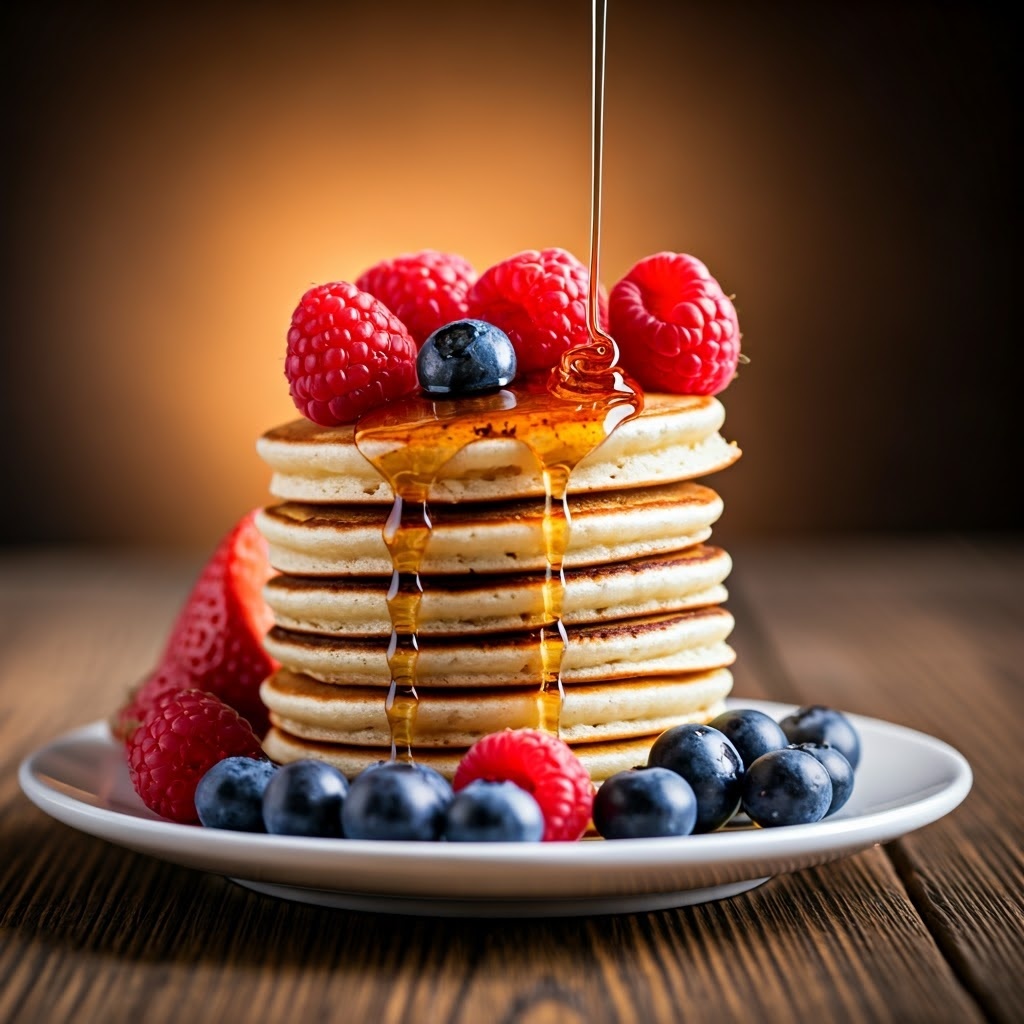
260;669;732;751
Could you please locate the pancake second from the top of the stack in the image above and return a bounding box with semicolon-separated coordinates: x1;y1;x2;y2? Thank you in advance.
256;479;722;577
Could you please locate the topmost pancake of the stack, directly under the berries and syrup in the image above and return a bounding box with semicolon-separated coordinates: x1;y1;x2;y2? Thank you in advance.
256;394;740;504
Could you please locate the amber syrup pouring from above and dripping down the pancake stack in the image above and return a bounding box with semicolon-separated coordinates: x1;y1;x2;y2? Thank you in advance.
355;0;643;760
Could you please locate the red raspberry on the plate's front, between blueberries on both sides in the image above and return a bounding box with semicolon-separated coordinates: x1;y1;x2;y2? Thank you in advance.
453;729;594;843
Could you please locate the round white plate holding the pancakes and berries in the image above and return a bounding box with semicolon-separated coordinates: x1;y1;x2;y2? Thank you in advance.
18;699;972;918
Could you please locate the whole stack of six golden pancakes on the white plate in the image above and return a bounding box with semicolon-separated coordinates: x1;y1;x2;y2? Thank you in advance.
257;394;739;782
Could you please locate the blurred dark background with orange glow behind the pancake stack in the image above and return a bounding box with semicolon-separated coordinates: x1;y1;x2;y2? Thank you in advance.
0;0;1022;549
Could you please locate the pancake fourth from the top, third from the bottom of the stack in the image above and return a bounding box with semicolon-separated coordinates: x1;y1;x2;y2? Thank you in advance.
264;606;735;688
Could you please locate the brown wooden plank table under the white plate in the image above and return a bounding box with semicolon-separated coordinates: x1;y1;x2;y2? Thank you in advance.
0;539;1024;1024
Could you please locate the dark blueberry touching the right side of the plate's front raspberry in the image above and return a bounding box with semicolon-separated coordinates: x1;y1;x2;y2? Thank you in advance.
594;768;697;839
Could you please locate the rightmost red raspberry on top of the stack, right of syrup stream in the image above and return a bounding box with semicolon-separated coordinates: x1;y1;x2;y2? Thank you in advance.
608;252;739;394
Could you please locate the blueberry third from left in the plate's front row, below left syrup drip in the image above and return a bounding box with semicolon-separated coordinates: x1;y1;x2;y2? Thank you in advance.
342;761;453;840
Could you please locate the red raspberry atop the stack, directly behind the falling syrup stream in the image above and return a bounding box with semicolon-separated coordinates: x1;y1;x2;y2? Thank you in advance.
468;249;608;373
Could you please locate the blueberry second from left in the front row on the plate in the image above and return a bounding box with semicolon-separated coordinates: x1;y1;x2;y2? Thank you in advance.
263;759;348;837
